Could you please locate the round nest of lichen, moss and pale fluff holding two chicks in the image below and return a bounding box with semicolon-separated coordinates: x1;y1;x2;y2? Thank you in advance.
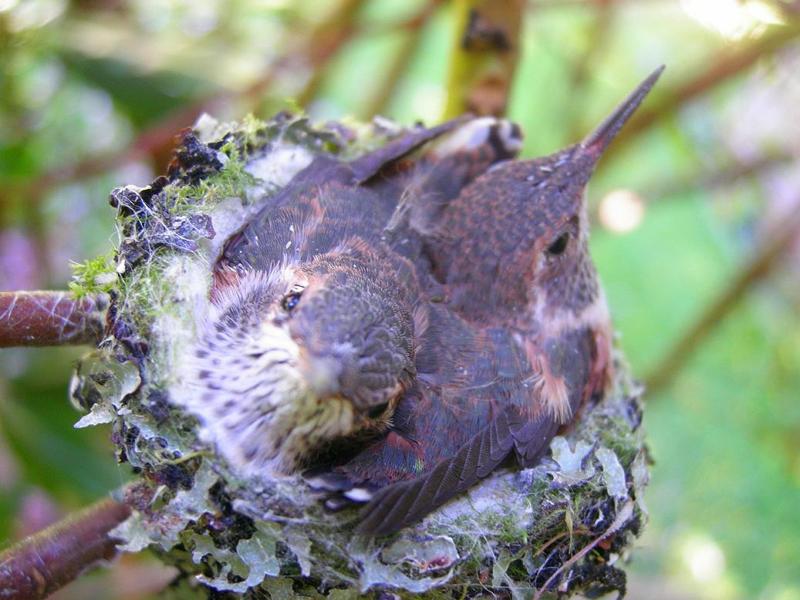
71;114;648;598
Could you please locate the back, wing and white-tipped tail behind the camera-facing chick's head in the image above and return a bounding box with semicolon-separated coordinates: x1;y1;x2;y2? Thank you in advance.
216;118;518;278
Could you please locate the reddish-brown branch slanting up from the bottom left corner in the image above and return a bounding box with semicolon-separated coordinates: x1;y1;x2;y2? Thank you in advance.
0;499;130;600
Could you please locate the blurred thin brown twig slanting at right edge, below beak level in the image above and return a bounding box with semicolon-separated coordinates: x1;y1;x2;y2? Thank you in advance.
645;204;800;392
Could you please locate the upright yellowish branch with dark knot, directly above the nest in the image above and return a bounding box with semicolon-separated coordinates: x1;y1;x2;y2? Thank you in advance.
444;0;524;119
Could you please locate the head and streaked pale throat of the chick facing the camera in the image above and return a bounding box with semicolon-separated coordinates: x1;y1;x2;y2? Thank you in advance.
179;239;414;476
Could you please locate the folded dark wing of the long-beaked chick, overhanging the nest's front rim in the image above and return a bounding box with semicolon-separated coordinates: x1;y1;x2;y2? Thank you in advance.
358;328;597;535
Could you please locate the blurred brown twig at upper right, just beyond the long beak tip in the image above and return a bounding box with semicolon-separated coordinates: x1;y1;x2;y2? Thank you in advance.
604;23;800;163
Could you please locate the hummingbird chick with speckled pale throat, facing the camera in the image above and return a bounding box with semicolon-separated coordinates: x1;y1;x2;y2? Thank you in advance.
172;113;519;476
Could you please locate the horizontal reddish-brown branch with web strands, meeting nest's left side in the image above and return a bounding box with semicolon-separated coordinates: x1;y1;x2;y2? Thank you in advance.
0;292;108;348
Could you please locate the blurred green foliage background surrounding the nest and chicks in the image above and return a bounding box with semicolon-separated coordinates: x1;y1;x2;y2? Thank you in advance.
0;0;800;600
